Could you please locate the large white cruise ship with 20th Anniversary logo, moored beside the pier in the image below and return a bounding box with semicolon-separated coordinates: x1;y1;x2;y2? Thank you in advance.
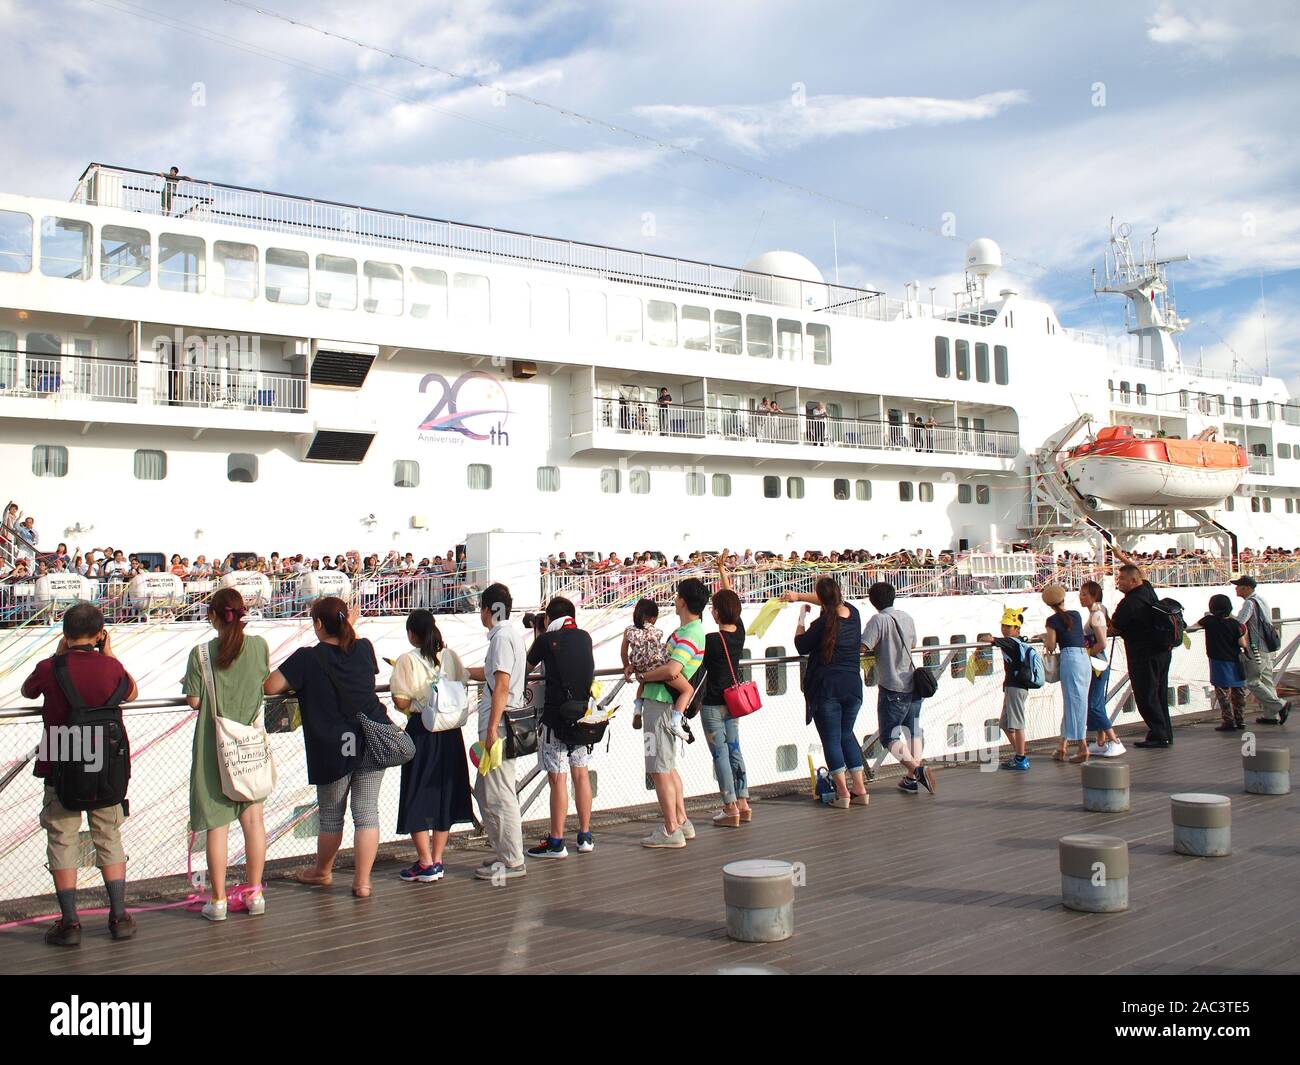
0;164;1300;910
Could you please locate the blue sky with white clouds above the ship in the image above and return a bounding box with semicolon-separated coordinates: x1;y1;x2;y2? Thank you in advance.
0;0;1300;394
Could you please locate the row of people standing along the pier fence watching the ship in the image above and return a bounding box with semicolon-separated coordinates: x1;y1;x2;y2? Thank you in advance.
22;554;1291;947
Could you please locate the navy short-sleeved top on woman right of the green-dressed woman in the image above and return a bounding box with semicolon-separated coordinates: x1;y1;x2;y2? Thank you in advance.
280;640;387;784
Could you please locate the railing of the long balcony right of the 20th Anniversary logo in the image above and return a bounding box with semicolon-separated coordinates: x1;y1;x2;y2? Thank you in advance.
595;397;1021;458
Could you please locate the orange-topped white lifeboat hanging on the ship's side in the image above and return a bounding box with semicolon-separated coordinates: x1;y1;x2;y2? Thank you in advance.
1061;425;1249;510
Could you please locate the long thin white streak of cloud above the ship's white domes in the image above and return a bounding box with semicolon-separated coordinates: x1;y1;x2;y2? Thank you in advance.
636;88;1028;155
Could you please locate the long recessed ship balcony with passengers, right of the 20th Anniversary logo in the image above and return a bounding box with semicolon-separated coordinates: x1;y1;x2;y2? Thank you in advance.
571;395;1021;469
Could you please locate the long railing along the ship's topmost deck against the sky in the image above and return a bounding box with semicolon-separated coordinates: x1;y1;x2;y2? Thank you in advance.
73;163;897;320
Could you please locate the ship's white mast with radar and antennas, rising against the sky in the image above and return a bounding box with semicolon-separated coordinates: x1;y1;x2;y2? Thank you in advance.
1092;218;1188;369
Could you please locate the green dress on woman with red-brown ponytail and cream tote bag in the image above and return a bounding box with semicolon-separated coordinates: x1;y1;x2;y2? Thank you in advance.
182;636;270;832
